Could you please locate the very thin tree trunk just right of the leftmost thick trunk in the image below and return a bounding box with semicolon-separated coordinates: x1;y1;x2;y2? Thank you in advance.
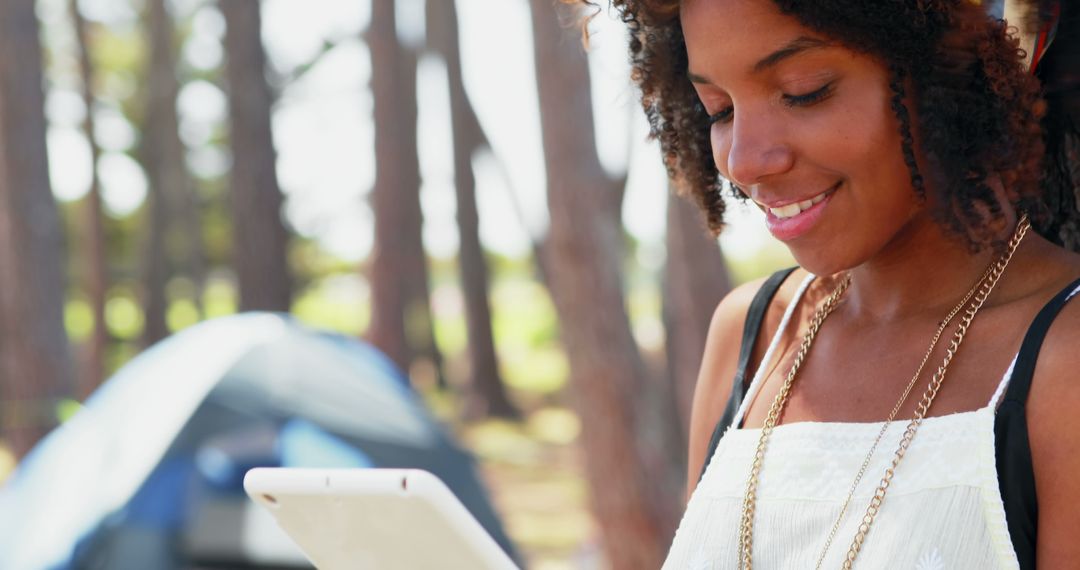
68;0;109;399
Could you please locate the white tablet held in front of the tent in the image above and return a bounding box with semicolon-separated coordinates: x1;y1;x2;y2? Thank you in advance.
244;467;517;570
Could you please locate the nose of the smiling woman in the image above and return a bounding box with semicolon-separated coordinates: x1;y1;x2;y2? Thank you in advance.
717;113;795;187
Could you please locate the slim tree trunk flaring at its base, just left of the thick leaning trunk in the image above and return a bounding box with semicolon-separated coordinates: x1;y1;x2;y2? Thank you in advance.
426;0;519;418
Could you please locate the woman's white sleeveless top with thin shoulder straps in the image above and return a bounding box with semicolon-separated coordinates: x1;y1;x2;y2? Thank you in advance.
663;276;1020;570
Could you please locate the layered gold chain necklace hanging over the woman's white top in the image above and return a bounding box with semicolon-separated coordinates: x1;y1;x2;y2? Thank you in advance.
739;215;1031;570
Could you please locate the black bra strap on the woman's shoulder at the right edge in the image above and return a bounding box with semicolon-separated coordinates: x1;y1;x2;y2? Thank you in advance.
994;275;1080;570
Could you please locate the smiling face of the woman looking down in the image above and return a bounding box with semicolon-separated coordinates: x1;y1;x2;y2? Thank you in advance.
680;0;921;274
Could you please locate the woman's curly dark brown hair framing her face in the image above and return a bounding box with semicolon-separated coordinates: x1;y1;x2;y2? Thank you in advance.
580;0;1080;250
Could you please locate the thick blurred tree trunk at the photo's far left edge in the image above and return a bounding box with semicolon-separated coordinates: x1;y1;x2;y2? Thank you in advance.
0;0;75;457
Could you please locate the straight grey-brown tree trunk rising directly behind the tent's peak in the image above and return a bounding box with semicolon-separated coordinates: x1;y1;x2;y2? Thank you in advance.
218;0;292;312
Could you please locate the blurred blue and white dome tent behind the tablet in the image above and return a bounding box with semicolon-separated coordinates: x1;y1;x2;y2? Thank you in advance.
0;313;514;570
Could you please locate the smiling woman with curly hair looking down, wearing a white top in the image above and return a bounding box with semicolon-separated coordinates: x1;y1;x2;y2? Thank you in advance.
596;0;1080;569
